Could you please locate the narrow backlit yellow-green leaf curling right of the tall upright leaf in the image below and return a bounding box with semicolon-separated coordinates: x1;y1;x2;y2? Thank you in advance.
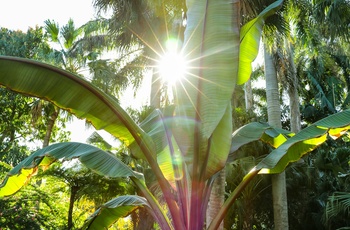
237;0;283;85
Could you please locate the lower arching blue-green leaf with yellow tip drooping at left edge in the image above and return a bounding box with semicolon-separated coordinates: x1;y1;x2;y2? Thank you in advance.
0;142;143;197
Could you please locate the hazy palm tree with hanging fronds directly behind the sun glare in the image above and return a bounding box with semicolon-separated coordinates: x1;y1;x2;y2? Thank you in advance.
94;0;185;108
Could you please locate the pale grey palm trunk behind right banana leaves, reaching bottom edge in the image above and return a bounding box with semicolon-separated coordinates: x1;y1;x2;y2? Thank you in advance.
264;48;288;230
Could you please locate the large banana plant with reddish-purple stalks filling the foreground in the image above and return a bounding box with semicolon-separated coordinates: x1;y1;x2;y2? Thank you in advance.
0;0;350;230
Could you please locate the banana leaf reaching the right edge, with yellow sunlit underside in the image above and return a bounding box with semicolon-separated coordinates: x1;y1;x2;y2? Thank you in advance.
256;110;350;173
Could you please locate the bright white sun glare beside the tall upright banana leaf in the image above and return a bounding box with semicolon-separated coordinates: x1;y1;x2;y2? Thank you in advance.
158;39;186;85
